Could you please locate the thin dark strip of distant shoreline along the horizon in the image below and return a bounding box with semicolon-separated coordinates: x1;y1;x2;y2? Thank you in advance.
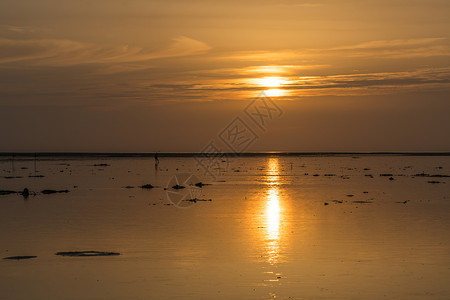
0;152;450;159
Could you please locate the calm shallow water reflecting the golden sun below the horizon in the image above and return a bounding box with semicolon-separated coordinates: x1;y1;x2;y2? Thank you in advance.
0;156;450;299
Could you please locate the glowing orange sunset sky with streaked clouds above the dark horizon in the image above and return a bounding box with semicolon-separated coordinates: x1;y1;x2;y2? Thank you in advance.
0;0;450;152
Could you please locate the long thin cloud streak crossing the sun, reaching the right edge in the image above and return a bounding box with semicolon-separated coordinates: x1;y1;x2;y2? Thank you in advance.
149;68;450;99
